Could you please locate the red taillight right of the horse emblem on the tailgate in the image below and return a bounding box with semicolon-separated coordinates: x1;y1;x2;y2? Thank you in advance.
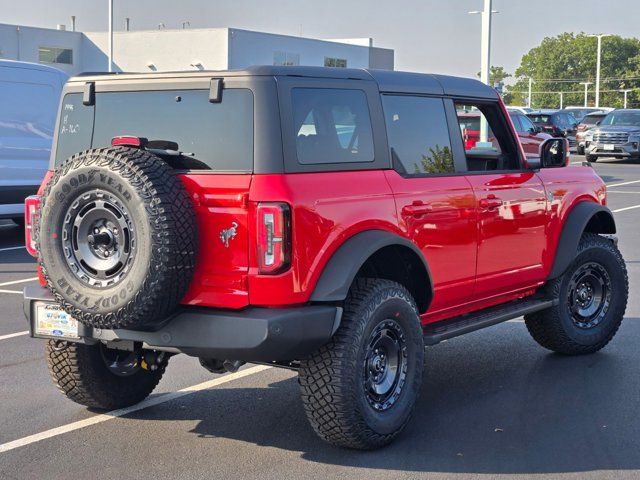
257;203;291;274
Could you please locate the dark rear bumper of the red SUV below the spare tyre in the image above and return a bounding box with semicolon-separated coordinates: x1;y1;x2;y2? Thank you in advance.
24;286;342;362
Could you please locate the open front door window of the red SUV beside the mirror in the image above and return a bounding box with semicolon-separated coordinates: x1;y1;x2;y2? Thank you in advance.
456;102;521;172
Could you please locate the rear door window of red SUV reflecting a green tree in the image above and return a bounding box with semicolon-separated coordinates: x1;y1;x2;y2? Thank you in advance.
382;95;455;176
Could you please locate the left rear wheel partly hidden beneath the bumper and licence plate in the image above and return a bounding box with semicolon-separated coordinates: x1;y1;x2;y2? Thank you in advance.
46;340;168;410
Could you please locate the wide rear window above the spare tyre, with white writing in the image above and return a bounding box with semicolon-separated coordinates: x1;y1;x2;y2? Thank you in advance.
56;89;253;172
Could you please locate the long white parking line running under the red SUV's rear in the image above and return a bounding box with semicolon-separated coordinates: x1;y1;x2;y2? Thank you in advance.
0;365;272;453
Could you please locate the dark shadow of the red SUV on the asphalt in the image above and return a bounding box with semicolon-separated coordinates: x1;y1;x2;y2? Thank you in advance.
126;318;640;474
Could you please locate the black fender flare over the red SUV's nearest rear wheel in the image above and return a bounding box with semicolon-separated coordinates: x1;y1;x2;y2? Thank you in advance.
310;230;433;308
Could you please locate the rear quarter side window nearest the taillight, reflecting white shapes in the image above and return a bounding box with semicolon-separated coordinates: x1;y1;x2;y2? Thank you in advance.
291;88;374;165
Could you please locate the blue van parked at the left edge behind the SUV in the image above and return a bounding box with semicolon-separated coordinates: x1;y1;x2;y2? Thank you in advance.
0;60;67;225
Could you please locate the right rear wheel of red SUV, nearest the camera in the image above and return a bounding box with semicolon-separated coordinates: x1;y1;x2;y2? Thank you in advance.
299;279;424;450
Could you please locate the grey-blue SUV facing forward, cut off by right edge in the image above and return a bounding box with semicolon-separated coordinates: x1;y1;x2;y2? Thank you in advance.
585;109;640;162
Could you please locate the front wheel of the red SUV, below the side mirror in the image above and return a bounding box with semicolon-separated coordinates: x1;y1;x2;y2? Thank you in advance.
524;233;629;355
